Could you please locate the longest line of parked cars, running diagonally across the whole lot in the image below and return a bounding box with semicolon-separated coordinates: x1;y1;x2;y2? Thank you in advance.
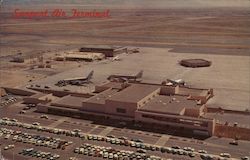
0;117;249;160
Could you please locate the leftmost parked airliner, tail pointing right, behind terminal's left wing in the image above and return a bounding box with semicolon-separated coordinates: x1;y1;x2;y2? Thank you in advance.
55;71;94;87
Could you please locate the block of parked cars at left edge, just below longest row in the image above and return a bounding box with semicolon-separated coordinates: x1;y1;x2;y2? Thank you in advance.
0;128;72;149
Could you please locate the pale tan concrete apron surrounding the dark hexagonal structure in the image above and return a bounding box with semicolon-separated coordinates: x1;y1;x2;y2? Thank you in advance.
27;48;250;110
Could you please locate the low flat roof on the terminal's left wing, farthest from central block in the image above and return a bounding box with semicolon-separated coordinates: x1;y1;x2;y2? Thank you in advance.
51;95;86;109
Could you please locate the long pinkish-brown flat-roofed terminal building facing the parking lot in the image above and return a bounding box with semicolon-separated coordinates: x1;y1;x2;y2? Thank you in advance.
24;82;215;136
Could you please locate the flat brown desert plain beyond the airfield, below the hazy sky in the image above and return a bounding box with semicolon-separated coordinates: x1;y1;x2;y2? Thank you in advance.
0;6;250;55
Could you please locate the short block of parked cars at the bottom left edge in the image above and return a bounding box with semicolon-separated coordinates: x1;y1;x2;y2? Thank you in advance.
19;148;60;160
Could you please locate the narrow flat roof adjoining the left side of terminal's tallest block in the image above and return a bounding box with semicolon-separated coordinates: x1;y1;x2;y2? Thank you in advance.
84;89;118;104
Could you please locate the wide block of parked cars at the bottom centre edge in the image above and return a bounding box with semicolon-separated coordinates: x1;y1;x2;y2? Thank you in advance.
74;143;162;160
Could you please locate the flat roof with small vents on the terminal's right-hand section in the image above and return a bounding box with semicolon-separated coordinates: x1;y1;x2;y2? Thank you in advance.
138;95;200;115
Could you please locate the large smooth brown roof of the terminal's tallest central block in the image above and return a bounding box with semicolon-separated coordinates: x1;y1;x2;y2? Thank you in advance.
108;84;160;103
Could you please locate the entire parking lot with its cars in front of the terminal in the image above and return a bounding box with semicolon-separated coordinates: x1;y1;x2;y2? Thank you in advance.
0;103;250;160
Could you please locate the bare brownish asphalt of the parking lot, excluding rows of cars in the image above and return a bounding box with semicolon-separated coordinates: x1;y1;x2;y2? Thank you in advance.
0;103;250;160
